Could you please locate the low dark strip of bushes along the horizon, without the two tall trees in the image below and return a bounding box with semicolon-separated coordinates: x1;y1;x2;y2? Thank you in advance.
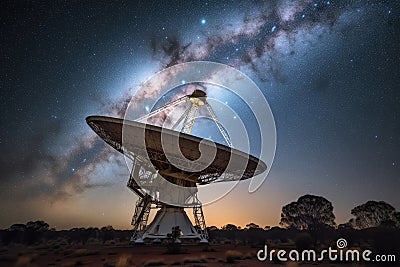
0;221;400;256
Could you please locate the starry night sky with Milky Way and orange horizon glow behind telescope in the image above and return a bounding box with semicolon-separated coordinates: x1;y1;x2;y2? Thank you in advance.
0;0;400;229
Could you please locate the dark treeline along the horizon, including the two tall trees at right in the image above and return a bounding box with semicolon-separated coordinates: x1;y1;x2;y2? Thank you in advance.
0;195;400;253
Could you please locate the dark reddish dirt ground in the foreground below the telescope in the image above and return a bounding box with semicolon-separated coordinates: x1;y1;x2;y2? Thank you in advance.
0;244;384;267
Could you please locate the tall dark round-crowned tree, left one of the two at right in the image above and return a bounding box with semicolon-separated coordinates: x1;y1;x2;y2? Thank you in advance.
280;195;336;231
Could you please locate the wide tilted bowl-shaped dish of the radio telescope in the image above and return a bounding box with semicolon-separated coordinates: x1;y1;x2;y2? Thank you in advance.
86;116;267;187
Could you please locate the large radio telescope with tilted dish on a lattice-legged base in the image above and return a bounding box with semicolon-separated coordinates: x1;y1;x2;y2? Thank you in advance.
86;90;267;243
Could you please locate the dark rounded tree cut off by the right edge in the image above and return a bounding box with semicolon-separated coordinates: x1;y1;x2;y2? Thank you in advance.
349;201;400;229
